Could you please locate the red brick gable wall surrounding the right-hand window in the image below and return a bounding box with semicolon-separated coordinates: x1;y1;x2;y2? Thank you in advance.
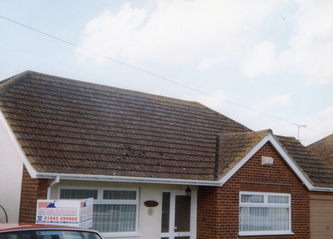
197;143;310;239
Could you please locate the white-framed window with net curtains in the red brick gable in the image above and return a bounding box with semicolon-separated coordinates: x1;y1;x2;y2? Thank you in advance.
239;192;292;235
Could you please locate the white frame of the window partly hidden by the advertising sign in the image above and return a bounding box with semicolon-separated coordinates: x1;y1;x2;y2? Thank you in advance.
58;186;140;237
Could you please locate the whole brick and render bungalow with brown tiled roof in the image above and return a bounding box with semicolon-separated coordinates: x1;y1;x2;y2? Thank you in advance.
0;71;333;239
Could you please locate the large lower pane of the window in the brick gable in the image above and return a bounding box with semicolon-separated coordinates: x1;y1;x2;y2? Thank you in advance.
239;207;289;231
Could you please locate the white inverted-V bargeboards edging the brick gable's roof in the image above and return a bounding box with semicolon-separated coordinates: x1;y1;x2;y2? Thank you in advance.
219;133;314;190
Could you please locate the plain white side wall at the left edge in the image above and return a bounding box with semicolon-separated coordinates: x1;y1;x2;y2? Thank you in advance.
0;113;23;223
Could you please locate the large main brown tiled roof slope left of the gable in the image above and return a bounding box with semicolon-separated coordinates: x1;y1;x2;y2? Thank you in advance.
0;71;250;180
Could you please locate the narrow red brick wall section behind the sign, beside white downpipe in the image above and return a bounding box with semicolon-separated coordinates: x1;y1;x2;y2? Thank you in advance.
19;167;48;223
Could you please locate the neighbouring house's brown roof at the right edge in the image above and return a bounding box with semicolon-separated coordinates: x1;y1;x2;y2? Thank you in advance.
307;134;333;168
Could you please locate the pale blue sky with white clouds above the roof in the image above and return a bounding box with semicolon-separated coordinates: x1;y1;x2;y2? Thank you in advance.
0;0;333;146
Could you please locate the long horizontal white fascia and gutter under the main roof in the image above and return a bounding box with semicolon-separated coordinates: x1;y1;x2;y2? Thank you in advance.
36;173;222;186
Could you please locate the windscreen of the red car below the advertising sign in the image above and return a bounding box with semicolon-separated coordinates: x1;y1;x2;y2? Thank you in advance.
0;230;102;239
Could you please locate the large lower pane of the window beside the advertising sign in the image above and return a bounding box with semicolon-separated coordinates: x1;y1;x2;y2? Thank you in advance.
93;204;136;232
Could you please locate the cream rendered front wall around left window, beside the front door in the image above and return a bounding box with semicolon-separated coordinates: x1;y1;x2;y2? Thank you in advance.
50;179;197;239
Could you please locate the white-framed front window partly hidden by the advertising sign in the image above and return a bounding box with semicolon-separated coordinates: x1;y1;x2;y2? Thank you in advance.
59;188;138;235
